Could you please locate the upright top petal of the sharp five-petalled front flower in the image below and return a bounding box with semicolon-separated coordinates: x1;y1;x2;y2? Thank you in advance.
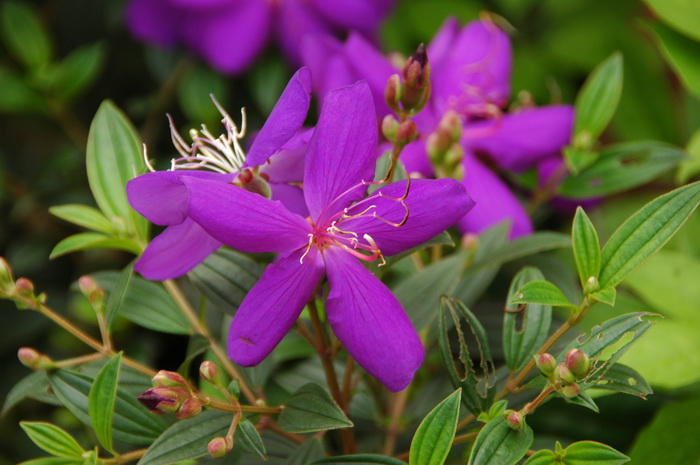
304;81;377;223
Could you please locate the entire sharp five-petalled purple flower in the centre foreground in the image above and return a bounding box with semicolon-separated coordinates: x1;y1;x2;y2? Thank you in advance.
183;82;473;391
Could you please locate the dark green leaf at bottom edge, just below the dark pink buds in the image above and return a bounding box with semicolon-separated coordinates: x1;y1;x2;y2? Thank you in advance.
138;410;233;465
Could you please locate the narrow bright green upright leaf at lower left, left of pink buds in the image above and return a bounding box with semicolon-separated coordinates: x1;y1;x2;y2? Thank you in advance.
88;352;122;452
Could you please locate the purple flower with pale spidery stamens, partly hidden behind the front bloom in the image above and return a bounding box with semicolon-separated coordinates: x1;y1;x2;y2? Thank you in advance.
126;68;311;280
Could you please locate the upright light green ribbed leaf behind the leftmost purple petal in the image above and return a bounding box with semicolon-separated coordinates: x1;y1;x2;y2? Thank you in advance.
86;100;148;240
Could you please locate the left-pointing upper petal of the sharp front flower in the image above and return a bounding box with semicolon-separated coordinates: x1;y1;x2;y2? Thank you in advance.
183;178;311;252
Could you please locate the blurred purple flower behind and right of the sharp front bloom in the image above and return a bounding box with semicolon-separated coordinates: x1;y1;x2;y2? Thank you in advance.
302;19;574;238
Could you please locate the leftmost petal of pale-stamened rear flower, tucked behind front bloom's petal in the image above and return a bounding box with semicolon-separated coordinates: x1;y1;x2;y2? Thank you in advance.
126;171;235;225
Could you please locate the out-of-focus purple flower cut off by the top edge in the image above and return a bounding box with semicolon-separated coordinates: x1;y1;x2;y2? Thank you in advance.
126;0;393;74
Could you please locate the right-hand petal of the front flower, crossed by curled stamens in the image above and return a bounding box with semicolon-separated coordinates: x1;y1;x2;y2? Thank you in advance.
338;178;474;255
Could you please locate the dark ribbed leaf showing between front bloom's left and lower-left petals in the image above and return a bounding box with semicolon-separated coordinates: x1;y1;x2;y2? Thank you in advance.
187;247;263;314
